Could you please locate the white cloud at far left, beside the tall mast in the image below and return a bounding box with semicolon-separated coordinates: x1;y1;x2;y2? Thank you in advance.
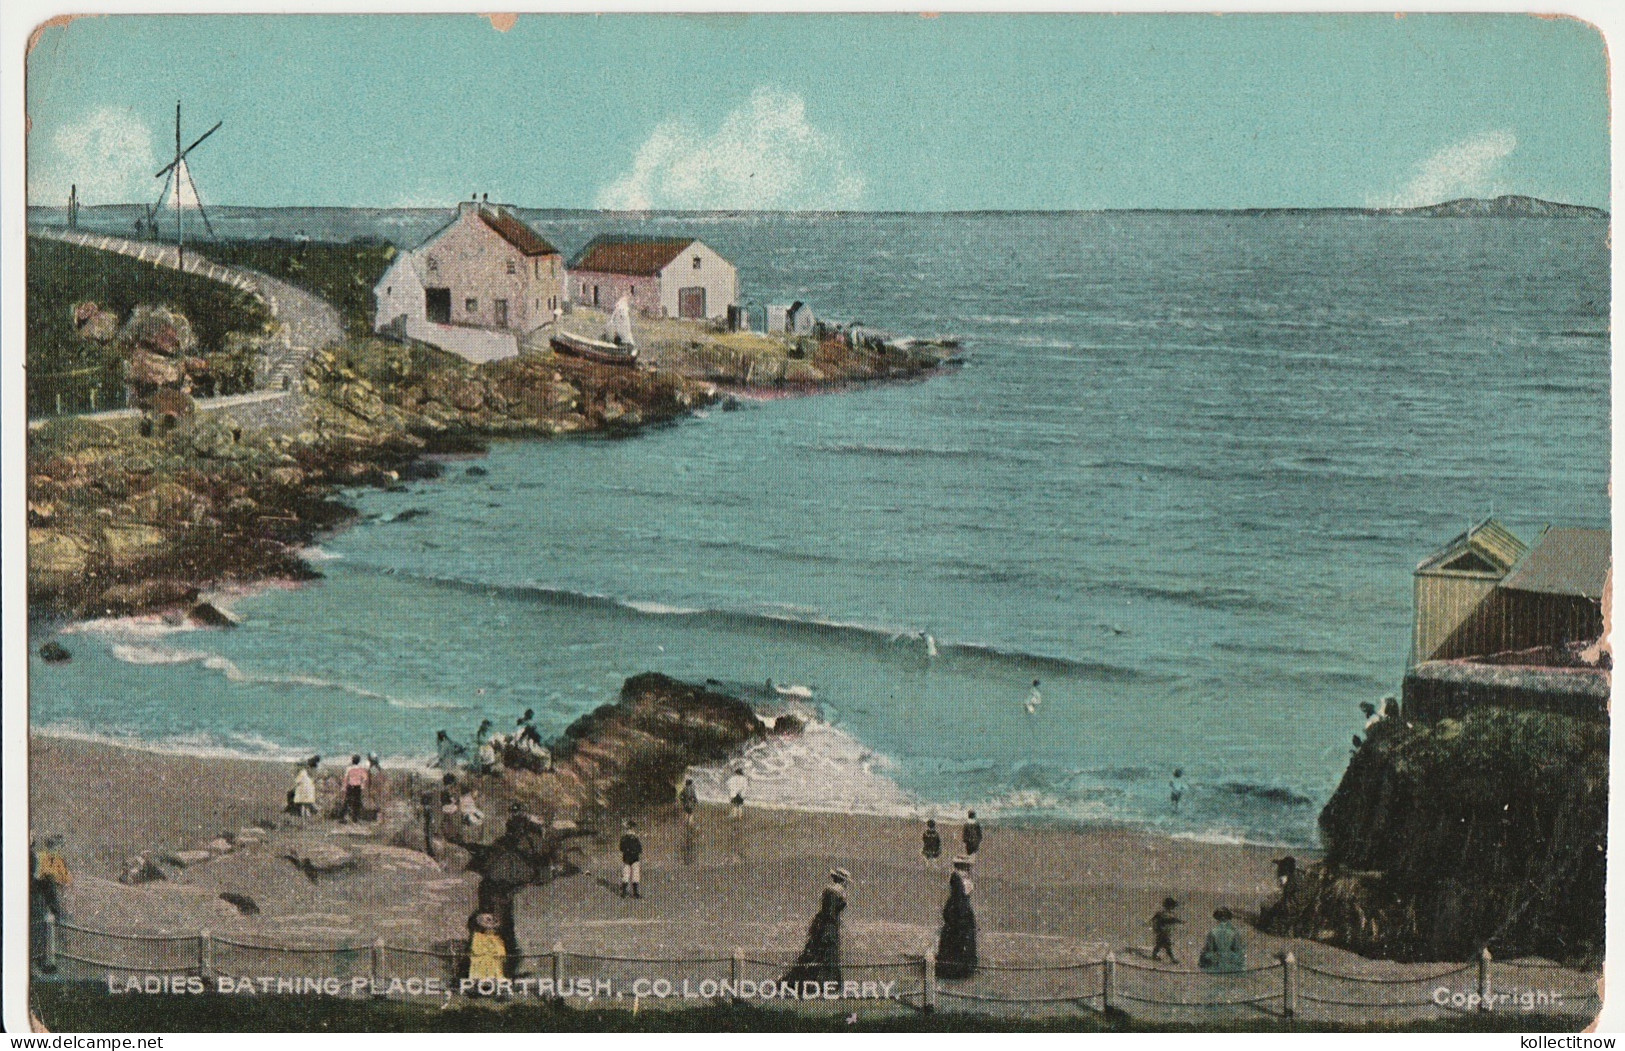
28;107;161;205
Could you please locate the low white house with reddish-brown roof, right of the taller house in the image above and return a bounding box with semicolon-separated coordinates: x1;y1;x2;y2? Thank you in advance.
569;234;739;318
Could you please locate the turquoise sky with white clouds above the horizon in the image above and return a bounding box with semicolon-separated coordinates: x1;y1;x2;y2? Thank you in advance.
28;13;1609;211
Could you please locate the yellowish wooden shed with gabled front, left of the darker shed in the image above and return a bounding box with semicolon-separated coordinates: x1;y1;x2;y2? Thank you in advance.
1411;518;1528;664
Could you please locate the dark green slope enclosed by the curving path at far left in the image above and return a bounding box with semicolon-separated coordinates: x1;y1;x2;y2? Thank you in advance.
26;237;271;416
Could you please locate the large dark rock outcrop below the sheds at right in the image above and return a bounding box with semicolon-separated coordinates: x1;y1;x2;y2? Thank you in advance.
1261;707;1609;962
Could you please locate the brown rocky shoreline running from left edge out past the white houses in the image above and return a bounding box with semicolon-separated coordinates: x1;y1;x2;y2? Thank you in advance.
28;316;939;622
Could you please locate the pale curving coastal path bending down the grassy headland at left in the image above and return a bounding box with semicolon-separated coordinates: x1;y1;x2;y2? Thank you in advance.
29;229;345;429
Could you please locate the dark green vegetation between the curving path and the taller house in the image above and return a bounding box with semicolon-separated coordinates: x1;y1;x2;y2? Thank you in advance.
197;237;395;338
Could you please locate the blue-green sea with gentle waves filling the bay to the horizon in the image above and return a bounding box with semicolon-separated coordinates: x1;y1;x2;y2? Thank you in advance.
29;208;1610;846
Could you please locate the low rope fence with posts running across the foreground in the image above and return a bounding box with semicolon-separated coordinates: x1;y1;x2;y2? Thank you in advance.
36;916;1601;1023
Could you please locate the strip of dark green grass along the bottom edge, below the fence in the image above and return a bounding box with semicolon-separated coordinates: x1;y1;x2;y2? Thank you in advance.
31;983;1591;1033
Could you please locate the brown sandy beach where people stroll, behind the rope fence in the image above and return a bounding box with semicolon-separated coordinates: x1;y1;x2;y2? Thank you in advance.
29;736;1319;963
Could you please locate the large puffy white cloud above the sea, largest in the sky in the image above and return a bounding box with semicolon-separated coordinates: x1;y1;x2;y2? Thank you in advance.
598;88;863;210
